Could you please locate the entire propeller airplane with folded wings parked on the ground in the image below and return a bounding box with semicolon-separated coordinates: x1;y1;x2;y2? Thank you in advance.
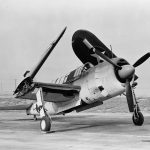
0;27;150;132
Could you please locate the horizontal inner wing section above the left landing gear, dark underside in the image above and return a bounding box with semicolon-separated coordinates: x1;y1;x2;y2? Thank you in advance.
16;82;81;102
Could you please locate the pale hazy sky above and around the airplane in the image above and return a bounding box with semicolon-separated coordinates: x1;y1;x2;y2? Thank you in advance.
0;0;150;96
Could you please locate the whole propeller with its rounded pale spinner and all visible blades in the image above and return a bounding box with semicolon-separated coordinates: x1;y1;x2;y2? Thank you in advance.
83;39;150;112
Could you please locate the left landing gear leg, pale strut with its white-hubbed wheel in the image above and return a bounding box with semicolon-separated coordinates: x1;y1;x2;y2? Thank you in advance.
36;88;52;132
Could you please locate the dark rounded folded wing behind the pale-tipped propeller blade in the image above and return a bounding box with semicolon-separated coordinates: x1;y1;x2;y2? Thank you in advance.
72;30;116;65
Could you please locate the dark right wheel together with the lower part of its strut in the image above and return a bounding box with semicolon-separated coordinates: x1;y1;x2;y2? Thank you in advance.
132;105;144;126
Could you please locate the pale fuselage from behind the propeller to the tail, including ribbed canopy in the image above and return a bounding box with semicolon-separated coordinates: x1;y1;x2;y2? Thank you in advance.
27;58;125;115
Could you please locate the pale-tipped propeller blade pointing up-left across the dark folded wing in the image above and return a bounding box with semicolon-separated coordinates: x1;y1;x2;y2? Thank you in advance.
83;39;122;69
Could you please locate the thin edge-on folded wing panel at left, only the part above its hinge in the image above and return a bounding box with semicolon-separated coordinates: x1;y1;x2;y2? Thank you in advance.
29;27;67;79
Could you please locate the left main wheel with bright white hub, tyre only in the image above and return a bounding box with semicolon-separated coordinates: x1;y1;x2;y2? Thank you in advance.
40;116;51;132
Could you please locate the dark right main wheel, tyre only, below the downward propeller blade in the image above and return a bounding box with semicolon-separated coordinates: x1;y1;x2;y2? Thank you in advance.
132;112;144;126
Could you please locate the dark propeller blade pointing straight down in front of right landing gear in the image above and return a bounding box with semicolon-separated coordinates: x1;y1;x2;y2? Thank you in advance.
126;80;134;112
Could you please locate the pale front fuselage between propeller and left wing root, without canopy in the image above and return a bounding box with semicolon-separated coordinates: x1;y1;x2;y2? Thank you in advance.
73;61;125;104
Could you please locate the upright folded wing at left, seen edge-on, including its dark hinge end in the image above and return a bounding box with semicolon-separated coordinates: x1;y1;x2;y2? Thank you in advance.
14;27;67;94
